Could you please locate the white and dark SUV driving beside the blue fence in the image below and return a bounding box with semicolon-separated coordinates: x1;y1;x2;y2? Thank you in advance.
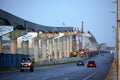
20;58;34;72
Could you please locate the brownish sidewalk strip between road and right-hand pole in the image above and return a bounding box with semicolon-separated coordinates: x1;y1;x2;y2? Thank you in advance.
105;59;117;80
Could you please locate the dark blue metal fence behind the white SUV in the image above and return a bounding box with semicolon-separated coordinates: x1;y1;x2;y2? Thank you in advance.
0;54;29;68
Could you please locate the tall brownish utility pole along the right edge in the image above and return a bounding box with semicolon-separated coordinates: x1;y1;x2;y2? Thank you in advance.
117;0;120;80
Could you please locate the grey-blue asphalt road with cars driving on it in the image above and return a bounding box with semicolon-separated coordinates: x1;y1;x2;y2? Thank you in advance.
0;54;114;80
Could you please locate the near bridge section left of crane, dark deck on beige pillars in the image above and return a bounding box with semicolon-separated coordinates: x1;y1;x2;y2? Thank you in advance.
0;9;76;62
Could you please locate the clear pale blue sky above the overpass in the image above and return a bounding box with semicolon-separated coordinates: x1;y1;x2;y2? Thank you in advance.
0;0;117;46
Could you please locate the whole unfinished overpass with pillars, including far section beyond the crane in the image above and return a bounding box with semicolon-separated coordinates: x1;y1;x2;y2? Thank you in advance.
0;9;98;61
